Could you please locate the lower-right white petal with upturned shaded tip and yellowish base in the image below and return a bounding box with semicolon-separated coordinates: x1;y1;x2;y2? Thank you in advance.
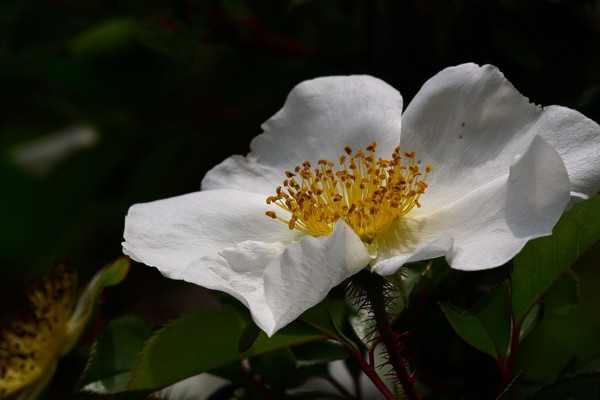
373;137;570;275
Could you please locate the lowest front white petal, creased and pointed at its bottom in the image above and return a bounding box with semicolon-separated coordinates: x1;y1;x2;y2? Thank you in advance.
182;223;370;336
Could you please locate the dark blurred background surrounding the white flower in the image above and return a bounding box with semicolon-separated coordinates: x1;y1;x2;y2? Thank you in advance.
0;0;600;396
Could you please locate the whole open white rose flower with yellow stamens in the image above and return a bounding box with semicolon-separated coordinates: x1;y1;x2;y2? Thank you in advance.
123;64;600;335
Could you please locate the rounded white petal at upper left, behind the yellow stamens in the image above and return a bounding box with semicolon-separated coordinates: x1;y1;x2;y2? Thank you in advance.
202;76;402;194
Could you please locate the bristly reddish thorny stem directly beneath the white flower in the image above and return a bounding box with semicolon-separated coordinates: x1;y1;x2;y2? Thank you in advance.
362;273;421;400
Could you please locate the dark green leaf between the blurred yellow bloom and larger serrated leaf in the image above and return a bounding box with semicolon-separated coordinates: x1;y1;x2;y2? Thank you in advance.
77;316;152;394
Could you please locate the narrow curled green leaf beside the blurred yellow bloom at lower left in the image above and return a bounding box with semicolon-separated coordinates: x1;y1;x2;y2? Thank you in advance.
61;257;129;355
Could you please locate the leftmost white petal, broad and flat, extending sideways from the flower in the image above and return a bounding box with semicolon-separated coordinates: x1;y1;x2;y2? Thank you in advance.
123;190;301;279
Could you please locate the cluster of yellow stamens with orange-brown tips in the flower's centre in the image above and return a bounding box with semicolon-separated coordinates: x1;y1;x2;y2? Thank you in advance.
266;142;433;242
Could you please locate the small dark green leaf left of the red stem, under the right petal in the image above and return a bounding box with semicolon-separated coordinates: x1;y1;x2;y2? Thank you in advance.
440;282;511;359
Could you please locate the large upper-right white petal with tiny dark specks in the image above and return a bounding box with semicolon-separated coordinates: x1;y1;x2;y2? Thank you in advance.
401;64;600;215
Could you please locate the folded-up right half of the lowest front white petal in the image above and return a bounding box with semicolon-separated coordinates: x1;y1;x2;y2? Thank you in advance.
265;222;371;334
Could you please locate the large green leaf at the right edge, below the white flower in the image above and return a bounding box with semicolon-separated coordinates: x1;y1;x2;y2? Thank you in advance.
511;196;600;322
